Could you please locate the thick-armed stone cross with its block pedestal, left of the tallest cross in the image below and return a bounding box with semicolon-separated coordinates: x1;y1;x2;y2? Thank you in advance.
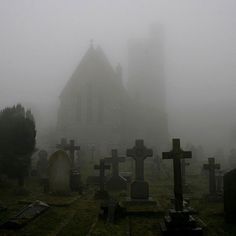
127;140;155;204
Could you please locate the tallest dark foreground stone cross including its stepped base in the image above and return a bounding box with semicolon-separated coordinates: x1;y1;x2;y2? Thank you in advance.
160;139;203;236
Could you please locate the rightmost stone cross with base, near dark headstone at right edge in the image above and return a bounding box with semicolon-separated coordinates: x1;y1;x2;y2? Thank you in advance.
203;157;222;201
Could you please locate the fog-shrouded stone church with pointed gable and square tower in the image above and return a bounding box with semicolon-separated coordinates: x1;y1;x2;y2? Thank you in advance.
57;31;168;156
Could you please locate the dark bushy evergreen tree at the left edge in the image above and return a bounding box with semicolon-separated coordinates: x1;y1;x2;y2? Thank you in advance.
0;104;36;187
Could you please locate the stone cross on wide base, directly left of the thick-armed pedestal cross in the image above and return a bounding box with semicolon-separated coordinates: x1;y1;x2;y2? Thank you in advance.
104;149;127;191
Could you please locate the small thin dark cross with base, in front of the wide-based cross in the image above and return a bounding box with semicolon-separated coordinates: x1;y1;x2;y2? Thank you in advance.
94;159;110;199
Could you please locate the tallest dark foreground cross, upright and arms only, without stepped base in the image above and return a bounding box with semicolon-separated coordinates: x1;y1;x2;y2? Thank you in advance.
162;139;192;211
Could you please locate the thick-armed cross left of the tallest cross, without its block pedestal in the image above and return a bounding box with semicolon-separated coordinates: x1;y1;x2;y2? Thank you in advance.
126;140;153;181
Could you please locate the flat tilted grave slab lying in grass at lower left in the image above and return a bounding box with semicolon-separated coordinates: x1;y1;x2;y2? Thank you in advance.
0;200;49;229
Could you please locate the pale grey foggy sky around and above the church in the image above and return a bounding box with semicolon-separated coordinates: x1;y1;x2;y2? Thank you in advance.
0;0;236;155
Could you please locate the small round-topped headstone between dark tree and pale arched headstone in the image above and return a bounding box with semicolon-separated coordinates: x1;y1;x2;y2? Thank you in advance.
37;150;48;181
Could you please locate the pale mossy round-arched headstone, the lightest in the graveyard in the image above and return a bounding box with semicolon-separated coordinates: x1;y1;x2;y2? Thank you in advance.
49;150;71;194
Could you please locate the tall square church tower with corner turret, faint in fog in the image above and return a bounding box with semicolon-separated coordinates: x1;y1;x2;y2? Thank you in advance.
127;26;168;148
